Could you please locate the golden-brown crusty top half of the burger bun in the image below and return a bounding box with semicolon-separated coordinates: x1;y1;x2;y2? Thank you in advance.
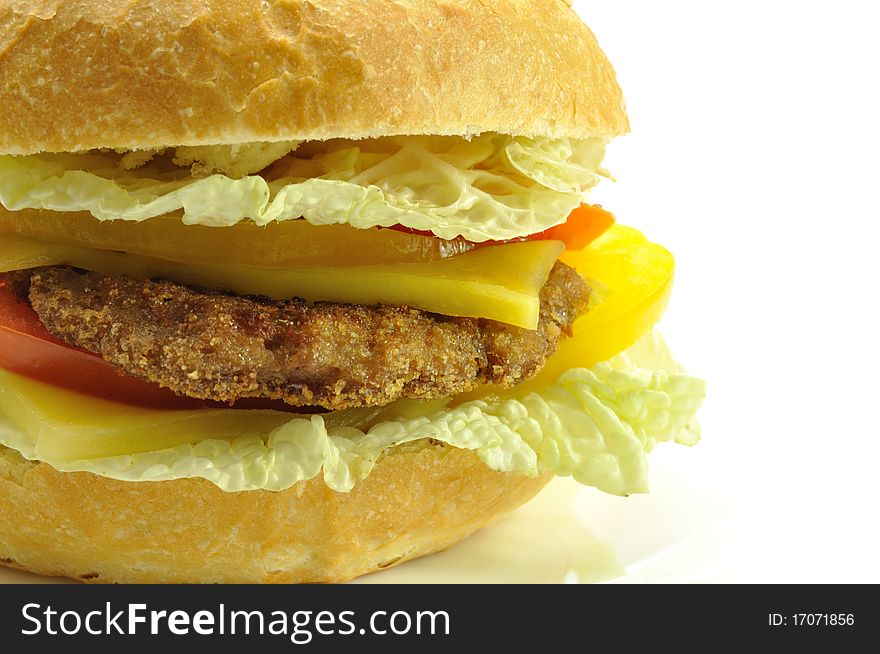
0;0;628;154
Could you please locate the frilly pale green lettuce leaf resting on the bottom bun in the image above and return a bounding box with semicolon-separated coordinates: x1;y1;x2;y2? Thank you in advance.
0;333;705;495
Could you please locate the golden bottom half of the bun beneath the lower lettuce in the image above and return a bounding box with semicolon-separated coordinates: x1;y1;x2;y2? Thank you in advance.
0;441;551;583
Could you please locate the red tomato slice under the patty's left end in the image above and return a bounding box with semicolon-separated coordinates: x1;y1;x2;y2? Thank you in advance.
0;280;315;413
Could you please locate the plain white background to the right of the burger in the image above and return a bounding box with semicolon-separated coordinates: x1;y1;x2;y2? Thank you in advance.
574;0;880;583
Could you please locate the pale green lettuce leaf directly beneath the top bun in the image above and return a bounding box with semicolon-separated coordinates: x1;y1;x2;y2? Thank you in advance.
0;133;605;242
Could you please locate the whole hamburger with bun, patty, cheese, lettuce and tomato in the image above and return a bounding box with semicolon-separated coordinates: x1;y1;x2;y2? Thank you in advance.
0;0;704;582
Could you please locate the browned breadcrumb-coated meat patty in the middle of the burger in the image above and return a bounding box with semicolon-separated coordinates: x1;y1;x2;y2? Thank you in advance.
19;263;590;409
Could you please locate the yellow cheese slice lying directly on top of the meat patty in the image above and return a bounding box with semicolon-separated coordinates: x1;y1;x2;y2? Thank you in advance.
0;235;565;329
